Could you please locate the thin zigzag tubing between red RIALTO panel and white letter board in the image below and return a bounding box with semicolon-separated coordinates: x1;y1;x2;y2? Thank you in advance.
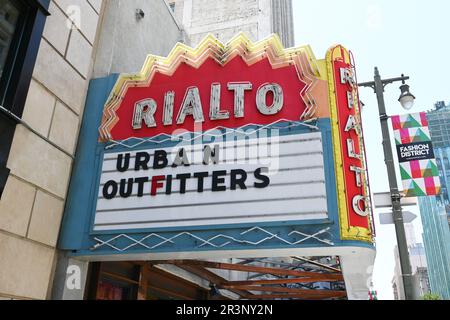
106;119;319;150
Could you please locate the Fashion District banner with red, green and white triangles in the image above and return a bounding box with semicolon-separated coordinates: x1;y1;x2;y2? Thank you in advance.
391;112;441;197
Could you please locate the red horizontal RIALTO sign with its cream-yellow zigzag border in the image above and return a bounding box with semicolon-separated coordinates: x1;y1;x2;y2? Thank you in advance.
100;36;316;141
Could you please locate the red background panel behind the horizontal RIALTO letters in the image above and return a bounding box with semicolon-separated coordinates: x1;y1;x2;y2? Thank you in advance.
106;56;306;140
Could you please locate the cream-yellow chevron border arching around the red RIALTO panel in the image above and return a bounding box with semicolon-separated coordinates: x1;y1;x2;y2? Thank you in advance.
99;33;320;141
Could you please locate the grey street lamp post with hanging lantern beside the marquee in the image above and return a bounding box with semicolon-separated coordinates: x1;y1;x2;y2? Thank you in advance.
359;68;415;300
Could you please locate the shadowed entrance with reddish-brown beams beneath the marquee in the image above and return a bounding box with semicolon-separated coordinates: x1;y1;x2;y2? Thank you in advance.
81;257;347;300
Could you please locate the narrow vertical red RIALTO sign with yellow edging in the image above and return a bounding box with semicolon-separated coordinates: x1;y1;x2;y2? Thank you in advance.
327;46;372;239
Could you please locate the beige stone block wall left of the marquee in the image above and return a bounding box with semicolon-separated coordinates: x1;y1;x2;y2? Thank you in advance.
0;0;104;299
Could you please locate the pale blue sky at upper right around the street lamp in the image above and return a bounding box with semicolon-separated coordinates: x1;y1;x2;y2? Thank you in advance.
292;0;450;299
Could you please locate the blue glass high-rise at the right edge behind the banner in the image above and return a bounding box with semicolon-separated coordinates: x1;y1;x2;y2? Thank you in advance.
419;102;450;299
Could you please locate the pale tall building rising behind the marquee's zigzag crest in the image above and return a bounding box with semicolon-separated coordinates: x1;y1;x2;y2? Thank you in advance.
169;0;294;47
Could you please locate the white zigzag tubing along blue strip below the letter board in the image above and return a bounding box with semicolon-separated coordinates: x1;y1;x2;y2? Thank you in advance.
91;227;334;252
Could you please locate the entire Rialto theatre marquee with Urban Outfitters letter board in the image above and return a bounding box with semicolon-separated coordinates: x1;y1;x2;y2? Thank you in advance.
61;34;373;255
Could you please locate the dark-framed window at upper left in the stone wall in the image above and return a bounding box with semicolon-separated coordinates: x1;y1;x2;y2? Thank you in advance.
0;0;50;197
